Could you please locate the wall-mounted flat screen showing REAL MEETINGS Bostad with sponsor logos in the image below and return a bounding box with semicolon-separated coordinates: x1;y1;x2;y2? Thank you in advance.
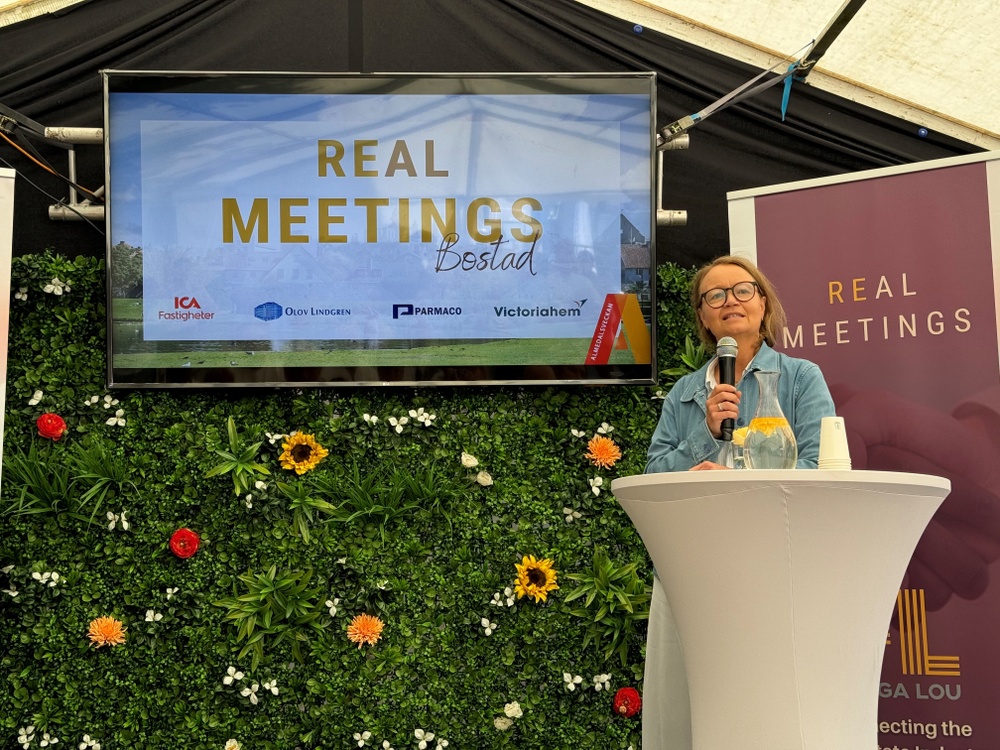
102;71;656;388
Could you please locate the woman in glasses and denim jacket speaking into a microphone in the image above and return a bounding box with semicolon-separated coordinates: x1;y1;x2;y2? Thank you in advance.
642;256;835;750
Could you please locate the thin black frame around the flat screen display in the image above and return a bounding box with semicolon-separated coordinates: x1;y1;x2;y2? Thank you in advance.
101;70;658;389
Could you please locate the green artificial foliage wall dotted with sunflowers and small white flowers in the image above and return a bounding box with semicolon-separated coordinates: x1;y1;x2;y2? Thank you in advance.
0;251;690;750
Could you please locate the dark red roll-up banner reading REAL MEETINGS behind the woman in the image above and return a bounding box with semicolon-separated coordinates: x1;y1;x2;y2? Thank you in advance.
752;162;1000;750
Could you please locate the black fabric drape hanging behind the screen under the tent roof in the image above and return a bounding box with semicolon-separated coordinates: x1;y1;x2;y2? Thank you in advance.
0;0;981;265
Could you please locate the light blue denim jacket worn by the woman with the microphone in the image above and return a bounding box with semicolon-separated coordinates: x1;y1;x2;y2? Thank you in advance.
646;343;835;474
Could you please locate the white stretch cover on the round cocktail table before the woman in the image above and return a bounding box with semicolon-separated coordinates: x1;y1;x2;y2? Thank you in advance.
611;470;951;750
